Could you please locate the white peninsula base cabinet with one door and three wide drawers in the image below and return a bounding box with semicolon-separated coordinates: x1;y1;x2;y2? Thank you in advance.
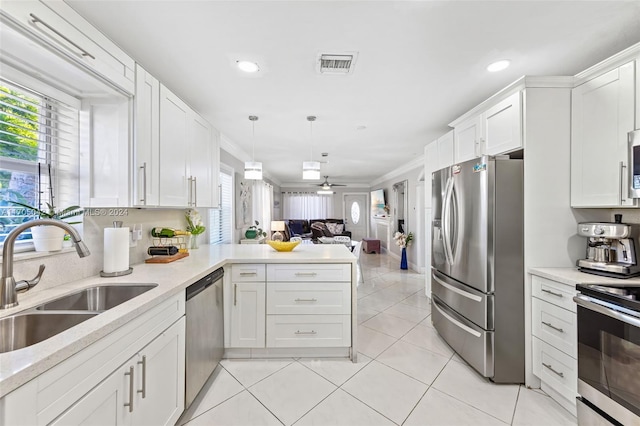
225;264;352;348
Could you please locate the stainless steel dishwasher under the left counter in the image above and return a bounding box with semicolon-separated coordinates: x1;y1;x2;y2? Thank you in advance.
185;268;224;410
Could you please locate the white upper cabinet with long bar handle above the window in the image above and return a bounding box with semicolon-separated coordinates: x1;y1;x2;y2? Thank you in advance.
0;0;135;95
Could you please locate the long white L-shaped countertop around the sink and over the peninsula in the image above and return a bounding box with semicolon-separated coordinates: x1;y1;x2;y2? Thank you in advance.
0;244;356;397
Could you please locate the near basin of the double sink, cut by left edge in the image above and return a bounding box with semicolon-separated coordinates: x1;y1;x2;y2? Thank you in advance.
0;311;98;353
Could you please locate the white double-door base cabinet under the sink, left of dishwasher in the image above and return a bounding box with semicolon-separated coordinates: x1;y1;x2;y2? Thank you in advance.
0;293;185;426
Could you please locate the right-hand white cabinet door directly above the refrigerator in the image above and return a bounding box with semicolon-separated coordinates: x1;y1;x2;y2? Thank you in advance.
482;92;522;155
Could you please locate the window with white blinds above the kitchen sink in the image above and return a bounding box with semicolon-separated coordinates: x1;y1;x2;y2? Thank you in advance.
0;76;80;242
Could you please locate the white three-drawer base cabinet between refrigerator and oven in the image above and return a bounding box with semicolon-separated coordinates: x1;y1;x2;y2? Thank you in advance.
531;275;578;415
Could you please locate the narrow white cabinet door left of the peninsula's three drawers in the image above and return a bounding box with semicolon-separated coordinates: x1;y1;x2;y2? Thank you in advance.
231;282;266;348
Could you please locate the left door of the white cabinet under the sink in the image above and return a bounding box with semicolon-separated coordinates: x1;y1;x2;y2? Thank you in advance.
51;358;137;426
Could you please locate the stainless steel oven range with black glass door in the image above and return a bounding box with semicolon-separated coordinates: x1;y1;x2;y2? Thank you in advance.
573;281;640;425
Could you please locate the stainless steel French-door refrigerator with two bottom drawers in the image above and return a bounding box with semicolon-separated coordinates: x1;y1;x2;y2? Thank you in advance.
431;156;524;383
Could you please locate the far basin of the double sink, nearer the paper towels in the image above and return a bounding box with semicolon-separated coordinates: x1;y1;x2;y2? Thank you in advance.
36;284;158;312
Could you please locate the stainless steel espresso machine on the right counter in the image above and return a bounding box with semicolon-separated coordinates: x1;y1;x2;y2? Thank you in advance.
577;214;640;278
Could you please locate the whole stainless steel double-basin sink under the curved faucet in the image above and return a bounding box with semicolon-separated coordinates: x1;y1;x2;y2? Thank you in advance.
0;283;158;353
